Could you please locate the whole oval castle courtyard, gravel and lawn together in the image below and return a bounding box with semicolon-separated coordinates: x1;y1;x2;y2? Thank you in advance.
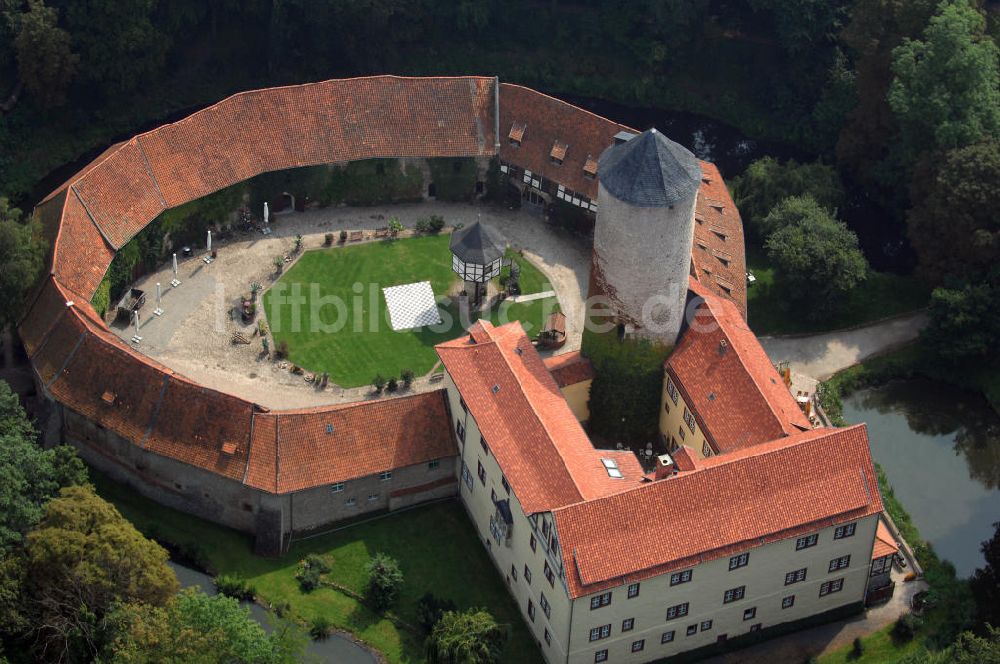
112;202;590;409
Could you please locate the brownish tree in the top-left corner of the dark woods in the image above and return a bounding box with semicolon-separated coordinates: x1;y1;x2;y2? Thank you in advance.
10;0;80;106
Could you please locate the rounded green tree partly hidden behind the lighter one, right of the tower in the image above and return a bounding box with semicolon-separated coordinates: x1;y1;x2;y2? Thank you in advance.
733;157;844;240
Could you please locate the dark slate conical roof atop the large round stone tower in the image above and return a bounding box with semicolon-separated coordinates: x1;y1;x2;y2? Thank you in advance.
598;129;701;207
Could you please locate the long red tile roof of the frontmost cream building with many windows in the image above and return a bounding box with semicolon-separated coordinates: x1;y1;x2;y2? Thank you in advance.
554;425;882;597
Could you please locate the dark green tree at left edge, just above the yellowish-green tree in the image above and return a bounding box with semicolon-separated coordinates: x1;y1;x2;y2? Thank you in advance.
0;381;87;554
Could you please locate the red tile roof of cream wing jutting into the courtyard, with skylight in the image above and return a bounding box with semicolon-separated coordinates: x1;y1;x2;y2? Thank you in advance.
437;321;642;514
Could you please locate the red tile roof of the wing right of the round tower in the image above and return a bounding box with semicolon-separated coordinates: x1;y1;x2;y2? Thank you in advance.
665;281;811;452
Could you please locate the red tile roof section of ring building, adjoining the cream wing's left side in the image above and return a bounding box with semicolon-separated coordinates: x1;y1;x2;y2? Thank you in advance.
247;390;458;493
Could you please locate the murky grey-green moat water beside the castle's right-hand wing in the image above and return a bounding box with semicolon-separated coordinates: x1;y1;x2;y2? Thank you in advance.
844;379;1000;577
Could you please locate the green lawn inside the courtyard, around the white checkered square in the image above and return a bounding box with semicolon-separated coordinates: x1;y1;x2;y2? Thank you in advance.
263;235;556;387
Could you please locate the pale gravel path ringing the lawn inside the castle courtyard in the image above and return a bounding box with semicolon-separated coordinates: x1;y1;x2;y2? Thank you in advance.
112;202;590;409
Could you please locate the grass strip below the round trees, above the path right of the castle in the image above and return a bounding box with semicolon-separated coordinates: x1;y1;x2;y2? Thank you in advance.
747;250;930;335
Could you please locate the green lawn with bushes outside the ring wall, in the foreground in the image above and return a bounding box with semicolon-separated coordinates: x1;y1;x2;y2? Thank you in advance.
91;470;541;664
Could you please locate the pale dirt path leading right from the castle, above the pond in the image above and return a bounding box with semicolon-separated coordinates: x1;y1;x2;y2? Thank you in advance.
760;311;927;380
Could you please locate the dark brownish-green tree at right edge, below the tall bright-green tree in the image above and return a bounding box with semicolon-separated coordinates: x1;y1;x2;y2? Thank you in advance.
907;139;1000;283
